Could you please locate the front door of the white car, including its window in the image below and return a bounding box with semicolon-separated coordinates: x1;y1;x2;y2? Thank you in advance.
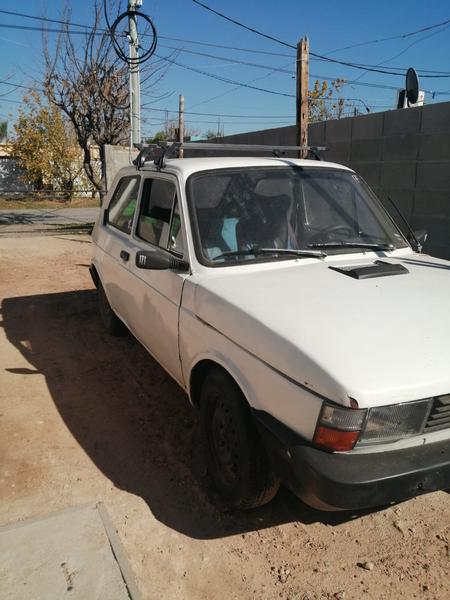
127;175;189;384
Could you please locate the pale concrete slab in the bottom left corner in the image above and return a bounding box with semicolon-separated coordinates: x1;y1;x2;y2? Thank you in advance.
0;506;139;600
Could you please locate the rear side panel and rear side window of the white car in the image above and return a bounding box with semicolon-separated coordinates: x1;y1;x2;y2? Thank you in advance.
100;175;141;325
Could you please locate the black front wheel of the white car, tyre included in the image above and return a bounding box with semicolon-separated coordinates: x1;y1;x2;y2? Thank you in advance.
200;369;280;509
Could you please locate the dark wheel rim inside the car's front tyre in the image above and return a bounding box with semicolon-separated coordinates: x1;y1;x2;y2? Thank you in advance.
208;393;239;488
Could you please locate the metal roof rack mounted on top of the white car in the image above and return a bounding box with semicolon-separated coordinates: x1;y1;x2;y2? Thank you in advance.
133;142;327;171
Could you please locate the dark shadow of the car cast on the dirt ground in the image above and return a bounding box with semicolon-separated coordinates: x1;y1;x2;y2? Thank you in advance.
0;290;384;539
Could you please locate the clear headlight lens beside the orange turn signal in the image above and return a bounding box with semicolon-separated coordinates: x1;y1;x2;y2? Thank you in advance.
358;399;433;445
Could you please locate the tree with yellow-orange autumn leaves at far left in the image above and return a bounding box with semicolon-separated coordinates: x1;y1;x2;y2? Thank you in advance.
11;92;82;198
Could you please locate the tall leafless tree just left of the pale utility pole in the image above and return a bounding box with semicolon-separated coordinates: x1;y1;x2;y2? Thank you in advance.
44;1;129;196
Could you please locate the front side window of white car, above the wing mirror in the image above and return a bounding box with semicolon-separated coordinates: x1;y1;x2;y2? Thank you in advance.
136;179;181;248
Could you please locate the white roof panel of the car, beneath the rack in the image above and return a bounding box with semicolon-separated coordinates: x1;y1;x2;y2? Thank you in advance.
120;156;353;179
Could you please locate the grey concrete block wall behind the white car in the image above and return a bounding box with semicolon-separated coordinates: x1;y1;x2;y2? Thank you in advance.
209;102;450;258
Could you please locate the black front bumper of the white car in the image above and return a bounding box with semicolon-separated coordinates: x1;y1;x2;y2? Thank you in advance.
253;411;450;510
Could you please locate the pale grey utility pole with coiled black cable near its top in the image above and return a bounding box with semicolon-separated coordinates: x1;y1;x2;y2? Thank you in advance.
128;0;142;148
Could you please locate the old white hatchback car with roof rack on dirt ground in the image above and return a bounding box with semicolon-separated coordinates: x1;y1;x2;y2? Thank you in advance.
91;144;450;510
